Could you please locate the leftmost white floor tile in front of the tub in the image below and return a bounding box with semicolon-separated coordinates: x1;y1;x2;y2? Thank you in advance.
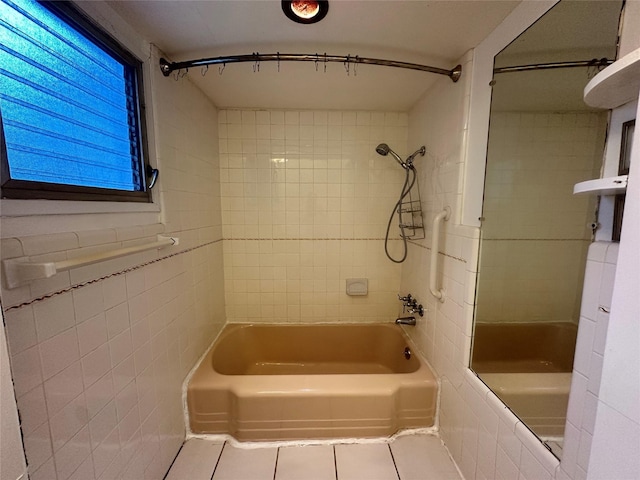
165;438;223;480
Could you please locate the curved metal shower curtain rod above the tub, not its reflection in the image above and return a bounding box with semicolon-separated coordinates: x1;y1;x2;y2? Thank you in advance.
160;52;462;82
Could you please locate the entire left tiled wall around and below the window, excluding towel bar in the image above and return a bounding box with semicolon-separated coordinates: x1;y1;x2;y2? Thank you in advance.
1;47;225;480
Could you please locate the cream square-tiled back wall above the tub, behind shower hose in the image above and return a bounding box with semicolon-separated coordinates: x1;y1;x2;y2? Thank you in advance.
218;110;407;322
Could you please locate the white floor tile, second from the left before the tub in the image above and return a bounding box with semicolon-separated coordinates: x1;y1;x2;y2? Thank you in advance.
212;444;278;480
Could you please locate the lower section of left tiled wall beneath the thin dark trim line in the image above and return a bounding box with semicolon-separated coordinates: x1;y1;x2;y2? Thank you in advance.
5;236;224;478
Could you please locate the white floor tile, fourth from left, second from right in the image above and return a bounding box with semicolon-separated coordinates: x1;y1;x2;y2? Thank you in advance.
335;443;398;480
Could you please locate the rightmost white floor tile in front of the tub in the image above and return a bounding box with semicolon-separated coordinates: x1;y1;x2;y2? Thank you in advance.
390;435;461;480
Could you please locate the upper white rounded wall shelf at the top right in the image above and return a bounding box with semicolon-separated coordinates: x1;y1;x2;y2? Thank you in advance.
584;48;640;109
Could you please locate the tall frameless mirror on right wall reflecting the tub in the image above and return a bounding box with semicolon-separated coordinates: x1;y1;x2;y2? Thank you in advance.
471;0;621;456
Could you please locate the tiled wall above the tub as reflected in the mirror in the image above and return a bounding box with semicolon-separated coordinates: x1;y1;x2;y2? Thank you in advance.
477;112;607;323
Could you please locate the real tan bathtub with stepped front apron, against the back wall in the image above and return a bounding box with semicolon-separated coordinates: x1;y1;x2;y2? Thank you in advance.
187;324;437;441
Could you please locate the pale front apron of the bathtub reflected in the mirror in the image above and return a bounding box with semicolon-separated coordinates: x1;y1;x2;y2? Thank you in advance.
480;373;571;438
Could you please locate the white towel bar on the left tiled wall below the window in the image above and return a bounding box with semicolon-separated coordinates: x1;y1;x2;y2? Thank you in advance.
2;235;179;288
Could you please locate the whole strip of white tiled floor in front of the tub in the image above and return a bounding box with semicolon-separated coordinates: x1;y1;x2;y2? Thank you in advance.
165;435;461;480
